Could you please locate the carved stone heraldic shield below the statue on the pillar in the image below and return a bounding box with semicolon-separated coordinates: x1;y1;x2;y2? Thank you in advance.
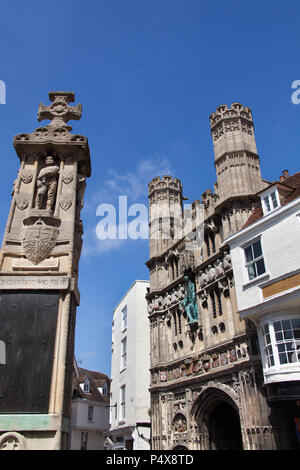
22;216;60;264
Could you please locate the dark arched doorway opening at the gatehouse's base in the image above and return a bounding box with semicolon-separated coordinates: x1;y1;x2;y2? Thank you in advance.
192;386;243;450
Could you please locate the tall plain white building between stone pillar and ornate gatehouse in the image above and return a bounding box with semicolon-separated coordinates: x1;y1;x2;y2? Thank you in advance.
105;281;150;450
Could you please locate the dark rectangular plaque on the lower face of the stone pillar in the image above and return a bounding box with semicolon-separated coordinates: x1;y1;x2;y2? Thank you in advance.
0;291;59;413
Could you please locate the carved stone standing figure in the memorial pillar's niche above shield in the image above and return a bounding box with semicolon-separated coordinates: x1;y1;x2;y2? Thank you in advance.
35;155;59;211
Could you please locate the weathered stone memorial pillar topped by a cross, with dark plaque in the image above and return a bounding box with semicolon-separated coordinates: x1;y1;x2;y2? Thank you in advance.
0;92;91;449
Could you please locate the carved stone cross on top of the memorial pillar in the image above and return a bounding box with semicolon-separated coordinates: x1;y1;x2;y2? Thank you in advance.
38;91;82;131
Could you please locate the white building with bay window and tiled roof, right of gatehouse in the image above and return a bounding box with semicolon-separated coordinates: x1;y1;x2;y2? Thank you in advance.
225;170;300;449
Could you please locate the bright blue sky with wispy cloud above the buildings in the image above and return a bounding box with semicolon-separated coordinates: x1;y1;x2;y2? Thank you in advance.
0;0;300;375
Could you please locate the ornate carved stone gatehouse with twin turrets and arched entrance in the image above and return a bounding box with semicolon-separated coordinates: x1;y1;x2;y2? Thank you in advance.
146;103;276;450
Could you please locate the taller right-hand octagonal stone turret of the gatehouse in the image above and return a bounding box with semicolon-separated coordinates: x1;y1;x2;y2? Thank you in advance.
210;103;263;204
